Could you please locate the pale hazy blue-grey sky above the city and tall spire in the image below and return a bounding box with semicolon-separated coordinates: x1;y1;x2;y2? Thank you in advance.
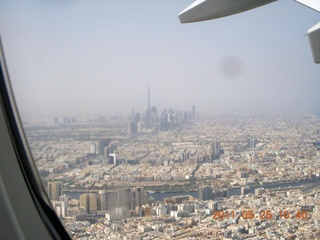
0;0;320;118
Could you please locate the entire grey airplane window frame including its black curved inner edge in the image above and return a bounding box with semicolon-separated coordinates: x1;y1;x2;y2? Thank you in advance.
0;36;71;239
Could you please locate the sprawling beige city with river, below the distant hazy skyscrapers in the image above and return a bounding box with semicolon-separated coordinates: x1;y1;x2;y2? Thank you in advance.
25;112;320;239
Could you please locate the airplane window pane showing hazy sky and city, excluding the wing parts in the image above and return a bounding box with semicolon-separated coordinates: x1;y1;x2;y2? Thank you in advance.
0;0;320;239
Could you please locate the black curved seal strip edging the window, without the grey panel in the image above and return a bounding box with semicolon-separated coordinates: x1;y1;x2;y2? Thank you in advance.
0;38;71;239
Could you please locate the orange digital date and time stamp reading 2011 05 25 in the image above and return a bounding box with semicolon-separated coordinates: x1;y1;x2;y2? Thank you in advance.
212;210;308;220
